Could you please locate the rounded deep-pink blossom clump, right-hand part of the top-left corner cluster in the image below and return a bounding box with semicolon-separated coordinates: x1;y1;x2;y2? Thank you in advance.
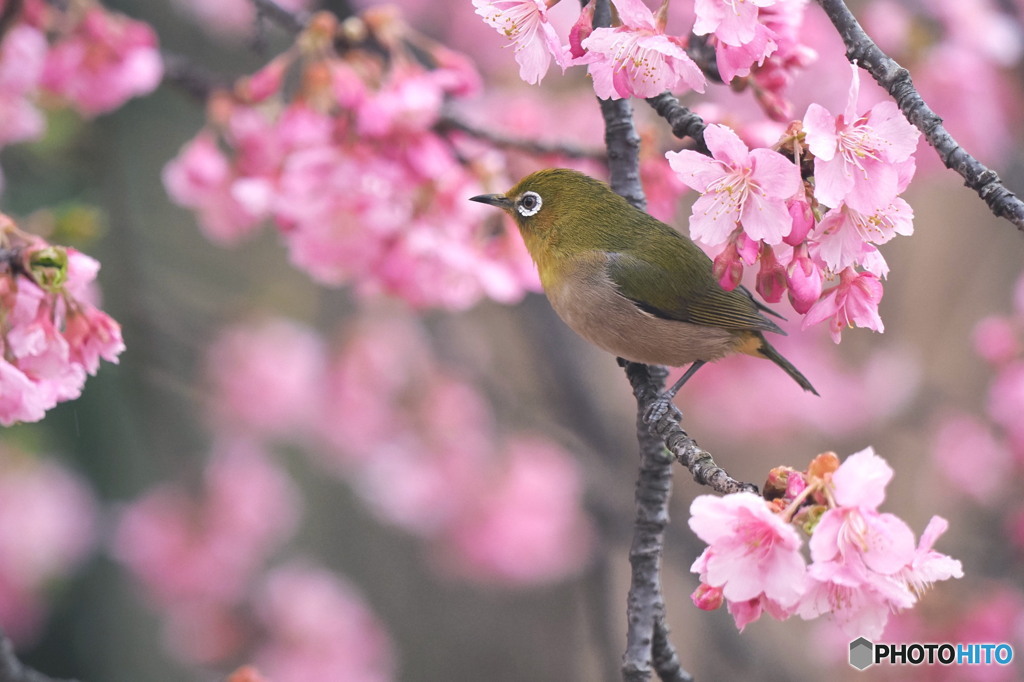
41;5;163;116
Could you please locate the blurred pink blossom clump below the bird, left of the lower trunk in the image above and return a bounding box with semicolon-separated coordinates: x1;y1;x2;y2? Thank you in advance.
438;438;591;586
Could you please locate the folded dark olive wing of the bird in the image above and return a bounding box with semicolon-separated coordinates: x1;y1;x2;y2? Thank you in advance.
605;253;785;334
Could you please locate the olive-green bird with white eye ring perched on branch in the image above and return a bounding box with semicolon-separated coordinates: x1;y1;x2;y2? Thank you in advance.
470;168;818;421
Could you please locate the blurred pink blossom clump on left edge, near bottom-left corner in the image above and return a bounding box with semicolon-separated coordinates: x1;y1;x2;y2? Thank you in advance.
0;450;96;644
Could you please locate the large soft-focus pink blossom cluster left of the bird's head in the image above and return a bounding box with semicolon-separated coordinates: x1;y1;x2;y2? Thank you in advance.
164;8;537;309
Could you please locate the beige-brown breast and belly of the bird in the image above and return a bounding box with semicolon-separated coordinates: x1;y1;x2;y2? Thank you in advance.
541;252;746;367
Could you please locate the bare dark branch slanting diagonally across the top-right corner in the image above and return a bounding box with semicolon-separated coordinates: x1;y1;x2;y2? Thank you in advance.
818;0;1024;231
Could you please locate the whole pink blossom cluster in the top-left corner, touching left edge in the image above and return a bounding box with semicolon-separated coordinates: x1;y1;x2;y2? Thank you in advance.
0;0;163;157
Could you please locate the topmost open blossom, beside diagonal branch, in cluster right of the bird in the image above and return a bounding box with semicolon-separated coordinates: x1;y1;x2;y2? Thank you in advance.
804;67;921;215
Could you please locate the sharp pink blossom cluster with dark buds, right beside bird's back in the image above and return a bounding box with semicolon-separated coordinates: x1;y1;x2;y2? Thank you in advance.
666;67;920;343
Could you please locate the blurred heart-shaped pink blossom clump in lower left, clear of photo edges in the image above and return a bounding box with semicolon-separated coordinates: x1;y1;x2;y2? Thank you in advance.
114;440;299;610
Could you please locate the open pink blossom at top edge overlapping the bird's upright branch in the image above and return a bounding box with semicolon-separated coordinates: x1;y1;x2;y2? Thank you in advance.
573;0;707;99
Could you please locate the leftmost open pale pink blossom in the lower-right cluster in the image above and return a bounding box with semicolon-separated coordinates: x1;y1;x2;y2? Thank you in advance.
689;493;806;608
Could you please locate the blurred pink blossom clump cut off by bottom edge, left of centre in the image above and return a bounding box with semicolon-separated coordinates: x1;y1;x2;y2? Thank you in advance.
253;561;395;682
